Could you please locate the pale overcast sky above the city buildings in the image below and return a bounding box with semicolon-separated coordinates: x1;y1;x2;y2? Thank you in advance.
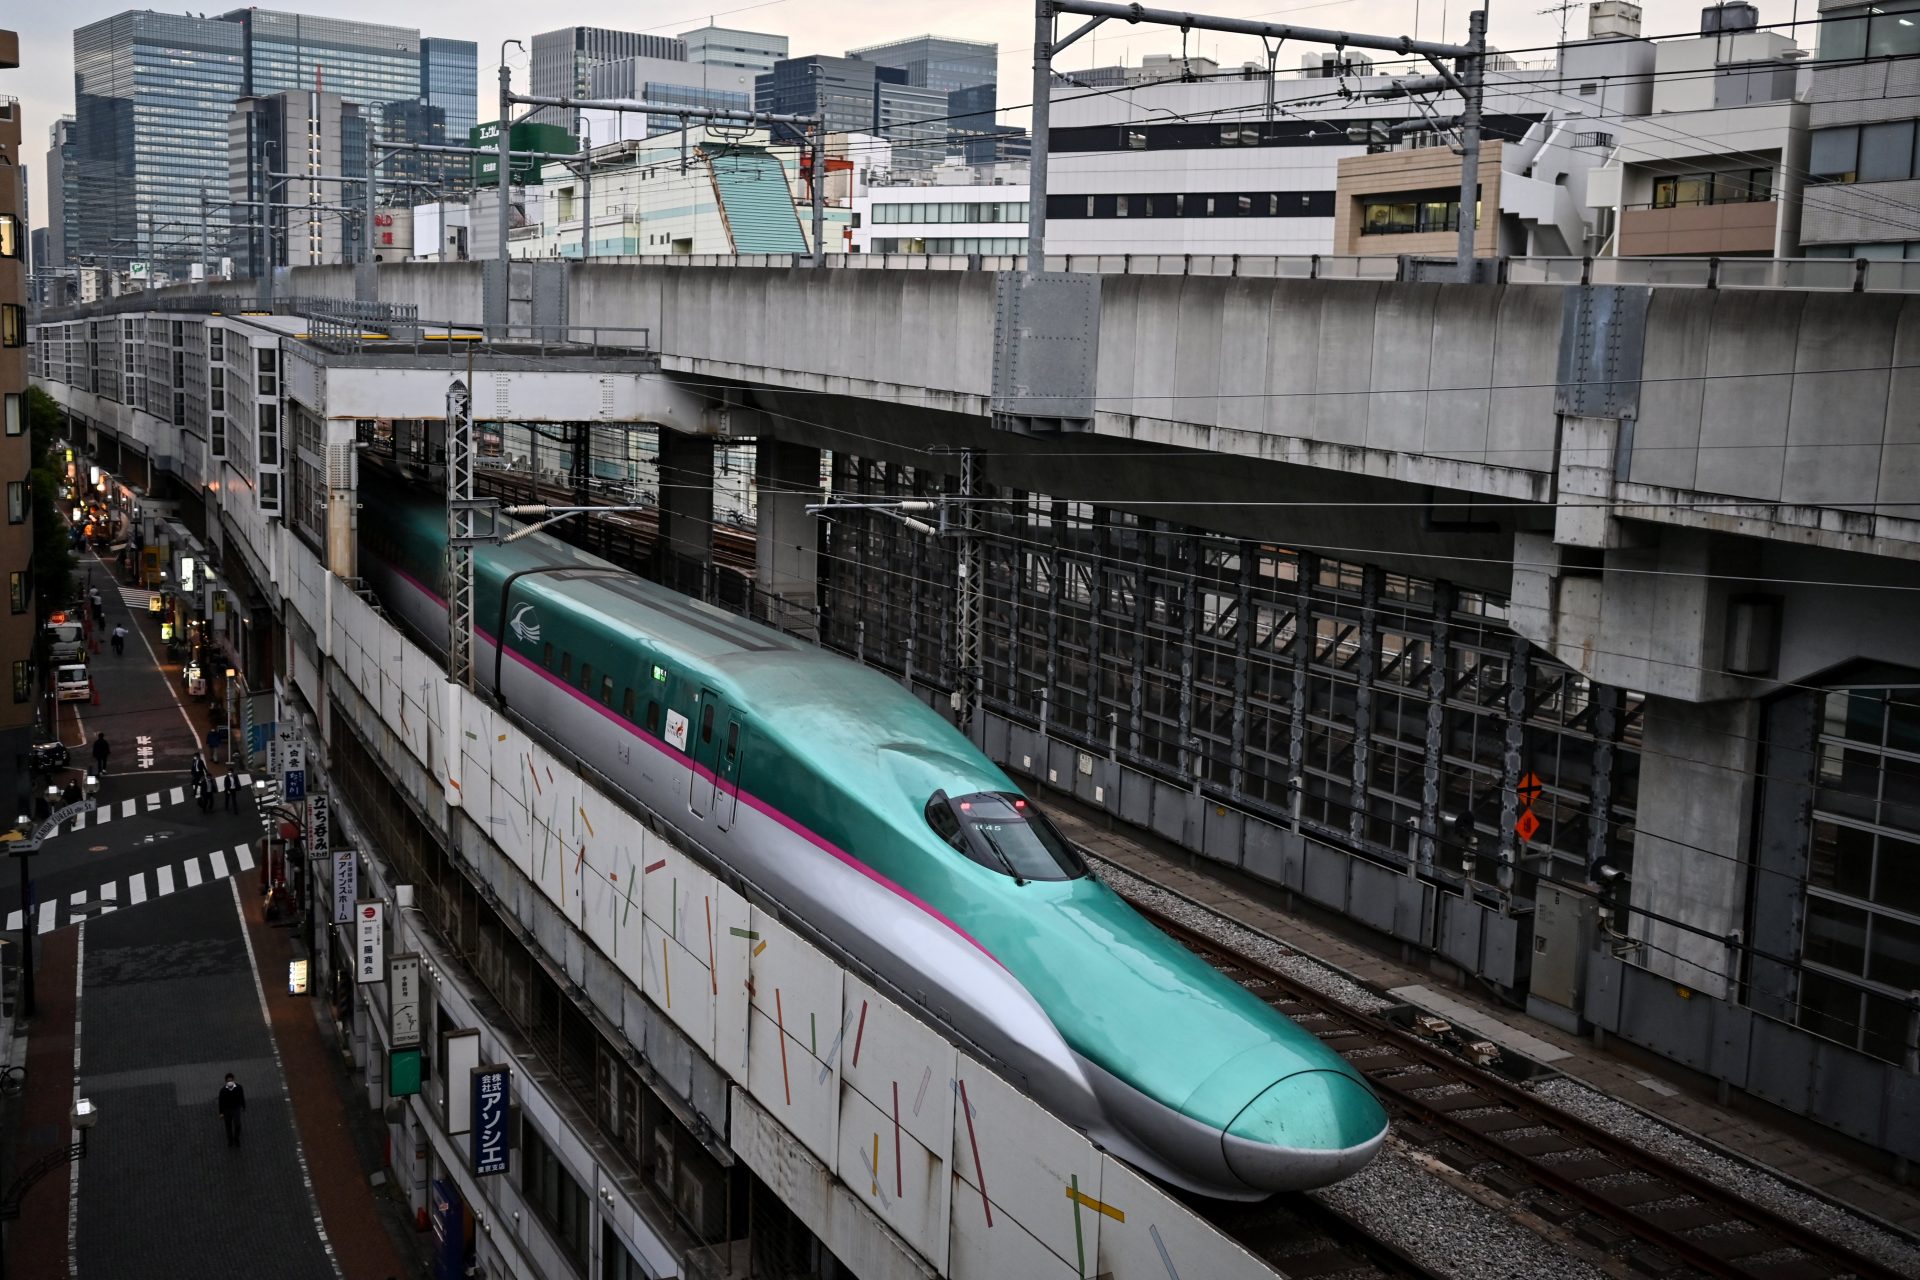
0;0;1816;226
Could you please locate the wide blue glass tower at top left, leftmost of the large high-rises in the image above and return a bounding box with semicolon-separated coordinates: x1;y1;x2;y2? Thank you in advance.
63;12;246;273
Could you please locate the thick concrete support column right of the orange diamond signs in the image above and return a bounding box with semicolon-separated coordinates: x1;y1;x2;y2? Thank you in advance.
1628;699;1761;996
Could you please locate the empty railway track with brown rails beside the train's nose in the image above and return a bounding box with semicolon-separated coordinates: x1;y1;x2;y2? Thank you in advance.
1135;902;1903;1280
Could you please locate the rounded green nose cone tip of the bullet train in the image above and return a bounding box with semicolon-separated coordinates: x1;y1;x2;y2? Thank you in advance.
1221;1071;1386;1192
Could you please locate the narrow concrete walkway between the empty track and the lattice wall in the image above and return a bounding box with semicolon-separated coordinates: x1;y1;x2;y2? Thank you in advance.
1046;796;1920;1232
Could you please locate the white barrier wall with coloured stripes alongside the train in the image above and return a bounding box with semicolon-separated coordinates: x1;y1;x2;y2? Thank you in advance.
326;578;1273;1280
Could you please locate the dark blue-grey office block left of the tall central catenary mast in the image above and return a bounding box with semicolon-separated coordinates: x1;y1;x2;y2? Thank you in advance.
755;54;947;171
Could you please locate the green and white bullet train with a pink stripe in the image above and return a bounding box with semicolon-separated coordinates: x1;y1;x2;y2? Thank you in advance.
359;466;1386;1199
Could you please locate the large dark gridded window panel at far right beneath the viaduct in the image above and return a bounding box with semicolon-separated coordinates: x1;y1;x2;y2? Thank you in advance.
1799;687;1920;1061
